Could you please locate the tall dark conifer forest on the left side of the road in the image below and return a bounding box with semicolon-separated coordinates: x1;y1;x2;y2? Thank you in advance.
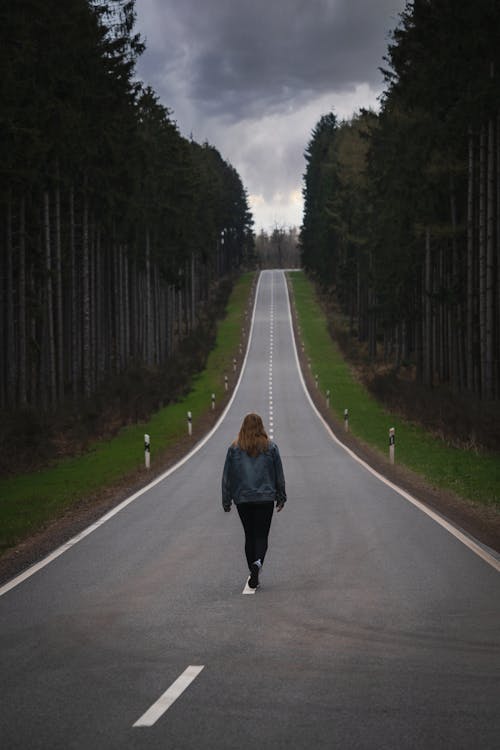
0;0;253;411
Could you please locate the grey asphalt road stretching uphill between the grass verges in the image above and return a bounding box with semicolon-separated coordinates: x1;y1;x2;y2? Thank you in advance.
0;271;500;750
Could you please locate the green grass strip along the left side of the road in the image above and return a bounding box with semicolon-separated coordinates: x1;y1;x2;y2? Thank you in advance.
0;273;254;554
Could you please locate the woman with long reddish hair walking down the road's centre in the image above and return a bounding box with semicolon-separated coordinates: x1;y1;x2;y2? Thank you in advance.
222;414;286;589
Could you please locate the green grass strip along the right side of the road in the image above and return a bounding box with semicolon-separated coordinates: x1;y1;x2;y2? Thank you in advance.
290;273;500;506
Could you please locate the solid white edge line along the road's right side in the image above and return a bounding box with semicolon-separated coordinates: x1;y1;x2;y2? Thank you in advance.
282;272;500;573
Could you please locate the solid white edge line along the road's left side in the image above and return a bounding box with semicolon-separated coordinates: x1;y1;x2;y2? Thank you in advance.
0;272;263;596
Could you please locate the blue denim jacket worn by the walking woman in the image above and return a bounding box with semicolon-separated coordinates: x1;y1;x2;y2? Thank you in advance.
222;441;286;510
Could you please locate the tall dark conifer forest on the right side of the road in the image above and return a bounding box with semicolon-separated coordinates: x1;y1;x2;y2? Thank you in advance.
301;0;500;399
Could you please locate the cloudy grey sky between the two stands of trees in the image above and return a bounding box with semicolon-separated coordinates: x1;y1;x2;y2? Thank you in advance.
136;0;405;231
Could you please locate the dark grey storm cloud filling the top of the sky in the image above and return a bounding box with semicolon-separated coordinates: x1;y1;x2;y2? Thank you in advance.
137;0;401;118
